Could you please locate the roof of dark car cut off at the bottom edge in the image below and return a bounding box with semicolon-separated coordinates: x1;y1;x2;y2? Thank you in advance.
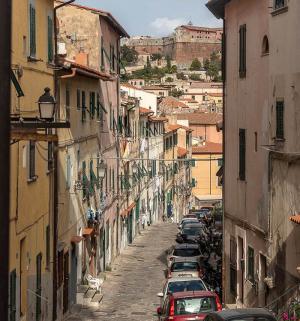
204;308;276;321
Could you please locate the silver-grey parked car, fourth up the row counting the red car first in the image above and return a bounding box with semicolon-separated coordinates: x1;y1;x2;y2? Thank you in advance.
167;243;203;268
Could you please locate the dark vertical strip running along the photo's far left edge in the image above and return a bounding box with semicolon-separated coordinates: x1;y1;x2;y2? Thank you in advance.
0;0;12;320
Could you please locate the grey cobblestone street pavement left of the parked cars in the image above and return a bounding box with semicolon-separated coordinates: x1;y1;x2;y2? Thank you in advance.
69;223;177;321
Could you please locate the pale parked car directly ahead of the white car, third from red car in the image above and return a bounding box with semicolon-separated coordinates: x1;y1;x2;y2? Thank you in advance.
167;258;204;278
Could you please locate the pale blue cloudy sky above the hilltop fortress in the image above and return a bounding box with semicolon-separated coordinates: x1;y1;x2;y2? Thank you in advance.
75;0;222;36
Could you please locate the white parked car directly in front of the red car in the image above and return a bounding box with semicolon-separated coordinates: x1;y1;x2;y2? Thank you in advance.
157;277;209;306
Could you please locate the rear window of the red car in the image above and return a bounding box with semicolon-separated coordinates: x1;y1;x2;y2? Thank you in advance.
175;297;217;315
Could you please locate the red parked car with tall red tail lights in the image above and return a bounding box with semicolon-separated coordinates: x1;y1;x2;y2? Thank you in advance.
157;291;222;321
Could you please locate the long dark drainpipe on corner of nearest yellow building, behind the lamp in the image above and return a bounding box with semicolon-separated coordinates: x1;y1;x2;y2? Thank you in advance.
52;0;75;321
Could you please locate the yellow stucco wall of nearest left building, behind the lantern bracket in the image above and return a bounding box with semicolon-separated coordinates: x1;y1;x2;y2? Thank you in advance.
10;0;54;320
